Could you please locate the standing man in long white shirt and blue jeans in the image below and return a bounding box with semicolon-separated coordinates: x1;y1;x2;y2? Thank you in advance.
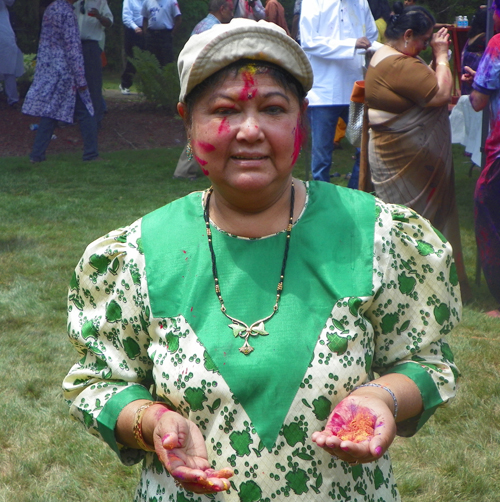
300;0;378;182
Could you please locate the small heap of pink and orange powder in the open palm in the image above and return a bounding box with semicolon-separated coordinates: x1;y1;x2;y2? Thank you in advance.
327;403;376;443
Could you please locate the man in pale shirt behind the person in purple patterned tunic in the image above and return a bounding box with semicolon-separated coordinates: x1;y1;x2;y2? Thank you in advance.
73;0;113;126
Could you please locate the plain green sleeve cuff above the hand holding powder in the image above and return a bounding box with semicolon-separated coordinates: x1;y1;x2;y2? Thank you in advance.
385;362;443;437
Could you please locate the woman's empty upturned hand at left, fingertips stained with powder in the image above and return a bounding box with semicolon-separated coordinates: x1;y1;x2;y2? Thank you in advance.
153;411;233;493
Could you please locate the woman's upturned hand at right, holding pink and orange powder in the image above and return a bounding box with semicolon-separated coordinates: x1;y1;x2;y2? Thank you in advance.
311;394;396;464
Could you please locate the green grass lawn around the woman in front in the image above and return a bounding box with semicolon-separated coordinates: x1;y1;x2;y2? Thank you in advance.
0;140;500;502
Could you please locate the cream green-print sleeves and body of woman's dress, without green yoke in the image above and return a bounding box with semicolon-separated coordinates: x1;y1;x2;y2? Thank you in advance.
64;184;461;502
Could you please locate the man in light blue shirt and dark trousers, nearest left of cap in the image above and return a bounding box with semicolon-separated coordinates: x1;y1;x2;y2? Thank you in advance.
142;0;182;66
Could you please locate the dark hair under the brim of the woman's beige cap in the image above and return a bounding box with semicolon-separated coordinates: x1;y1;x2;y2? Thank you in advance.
184;59;306;125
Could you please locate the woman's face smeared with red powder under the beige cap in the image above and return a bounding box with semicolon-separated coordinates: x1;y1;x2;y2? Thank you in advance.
179;66;305;193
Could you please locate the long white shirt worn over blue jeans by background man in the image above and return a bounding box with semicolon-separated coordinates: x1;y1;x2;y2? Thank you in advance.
300;0;378;106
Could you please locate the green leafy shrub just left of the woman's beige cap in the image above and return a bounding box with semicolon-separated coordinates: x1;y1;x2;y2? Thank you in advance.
130;47;180;112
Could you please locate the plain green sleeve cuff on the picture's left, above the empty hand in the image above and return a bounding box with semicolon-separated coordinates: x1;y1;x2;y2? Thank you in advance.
96;385;154;456
